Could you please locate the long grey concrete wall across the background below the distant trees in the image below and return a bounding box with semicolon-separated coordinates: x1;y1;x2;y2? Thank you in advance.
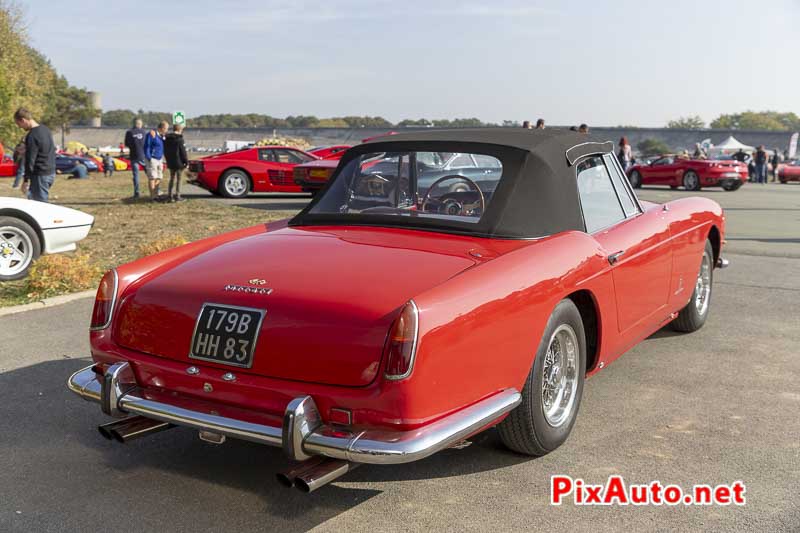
59;127;791;155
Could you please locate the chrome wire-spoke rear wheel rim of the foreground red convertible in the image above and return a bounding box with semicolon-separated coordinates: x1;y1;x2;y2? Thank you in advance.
542;324;578;427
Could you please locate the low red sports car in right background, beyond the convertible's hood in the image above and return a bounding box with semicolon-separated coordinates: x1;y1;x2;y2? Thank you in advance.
628;155;748;191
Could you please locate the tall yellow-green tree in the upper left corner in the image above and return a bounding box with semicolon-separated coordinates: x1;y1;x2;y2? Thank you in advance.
0;0;99;146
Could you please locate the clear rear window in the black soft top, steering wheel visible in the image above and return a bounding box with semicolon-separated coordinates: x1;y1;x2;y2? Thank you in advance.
309;151;503;223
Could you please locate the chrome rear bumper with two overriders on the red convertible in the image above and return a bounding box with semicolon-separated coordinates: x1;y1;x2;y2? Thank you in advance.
67;363;521;464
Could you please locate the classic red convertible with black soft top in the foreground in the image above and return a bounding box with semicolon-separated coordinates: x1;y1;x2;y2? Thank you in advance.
68;128;727;491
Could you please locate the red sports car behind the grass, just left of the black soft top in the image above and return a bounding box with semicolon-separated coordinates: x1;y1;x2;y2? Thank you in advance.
189;146;317;198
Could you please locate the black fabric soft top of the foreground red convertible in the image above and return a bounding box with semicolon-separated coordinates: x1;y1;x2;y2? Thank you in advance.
289;128;614;238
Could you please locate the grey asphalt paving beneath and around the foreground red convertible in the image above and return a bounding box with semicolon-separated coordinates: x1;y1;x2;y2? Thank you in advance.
0;184;800;533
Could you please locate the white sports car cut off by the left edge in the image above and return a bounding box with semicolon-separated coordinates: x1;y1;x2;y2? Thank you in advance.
0;197;94;281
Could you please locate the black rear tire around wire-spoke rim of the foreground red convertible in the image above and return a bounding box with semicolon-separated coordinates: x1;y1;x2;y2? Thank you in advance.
497;299;586;456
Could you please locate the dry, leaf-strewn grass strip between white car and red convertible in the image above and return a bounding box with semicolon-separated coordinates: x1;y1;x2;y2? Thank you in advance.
0;168;292;306
